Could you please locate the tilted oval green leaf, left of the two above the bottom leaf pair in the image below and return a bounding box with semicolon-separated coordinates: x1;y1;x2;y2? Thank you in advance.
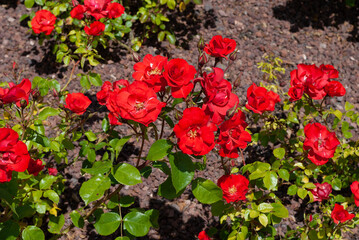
80;174;111;205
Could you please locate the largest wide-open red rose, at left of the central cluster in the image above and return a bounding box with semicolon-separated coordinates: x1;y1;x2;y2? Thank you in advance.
106;81;166;126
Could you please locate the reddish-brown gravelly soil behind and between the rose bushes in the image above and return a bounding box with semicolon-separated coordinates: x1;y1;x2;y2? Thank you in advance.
0;0;359;240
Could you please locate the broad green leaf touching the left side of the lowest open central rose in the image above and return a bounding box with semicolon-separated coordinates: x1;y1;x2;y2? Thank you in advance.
192;178;223;204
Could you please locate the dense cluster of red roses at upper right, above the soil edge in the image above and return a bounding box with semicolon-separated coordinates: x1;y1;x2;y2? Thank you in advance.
288;64;346;101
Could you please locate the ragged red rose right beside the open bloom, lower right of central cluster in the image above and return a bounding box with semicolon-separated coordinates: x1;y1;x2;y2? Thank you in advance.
217;111;252;158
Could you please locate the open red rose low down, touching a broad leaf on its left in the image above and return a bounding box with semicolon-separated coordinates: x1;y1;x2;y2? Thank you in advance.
217;174;249;203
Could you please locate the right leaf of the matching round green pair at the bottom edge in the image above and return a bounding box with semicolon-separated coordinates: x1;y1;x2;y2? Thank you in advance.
123;212;151;237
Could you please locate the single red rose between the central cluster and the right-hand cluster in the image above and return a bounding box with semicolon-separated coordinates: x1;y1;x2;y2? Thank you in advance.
246;83;280;114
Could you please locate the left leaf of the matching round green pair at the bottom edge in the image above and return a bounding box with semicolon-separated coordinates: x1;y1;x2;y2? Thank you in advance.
94;212;121;236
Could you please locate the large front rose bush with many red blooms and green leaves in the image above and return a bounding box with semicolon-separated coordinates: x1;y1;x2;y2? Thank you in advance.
0;34;359;240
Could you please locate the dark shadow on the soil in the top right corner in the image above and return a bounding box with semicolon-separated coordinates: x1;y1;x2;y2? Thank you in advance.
273;0;359;42
